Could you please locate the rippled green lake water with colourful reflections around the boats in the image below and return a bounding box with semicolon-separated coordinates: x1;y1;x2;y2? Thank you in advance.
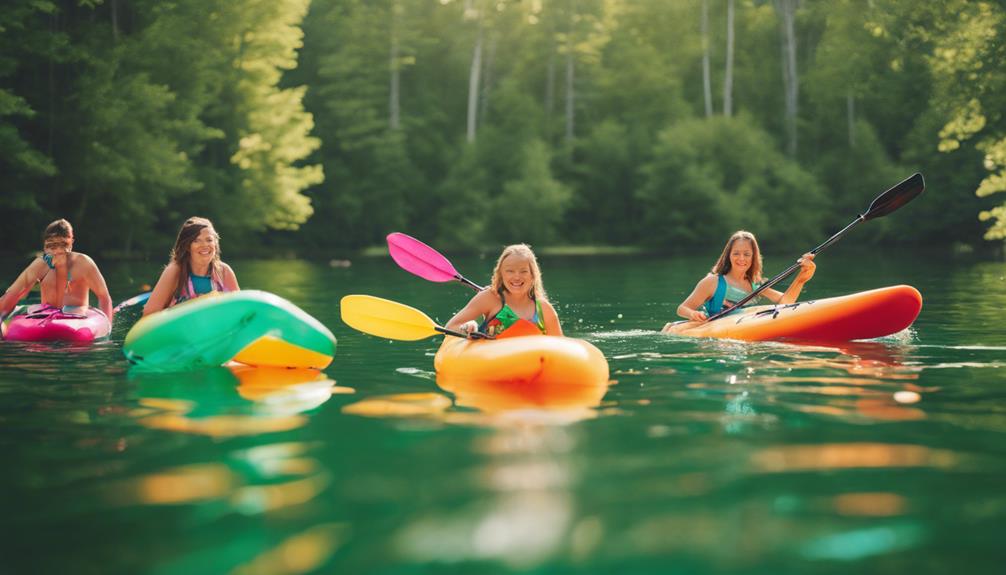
0;252;1006;574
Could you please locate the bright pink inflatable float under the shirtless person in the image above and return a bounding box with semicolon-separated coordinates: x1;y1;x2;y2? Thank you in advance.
4;305;112;343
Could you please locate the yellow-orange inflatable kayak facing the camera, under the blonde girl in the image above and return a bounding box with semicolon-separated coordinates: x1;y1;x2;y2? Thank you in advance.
434;335;609;411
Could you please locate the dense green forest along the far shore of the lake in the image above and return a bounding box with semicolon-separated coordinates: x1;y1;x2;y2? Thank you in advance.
0;0;1006;253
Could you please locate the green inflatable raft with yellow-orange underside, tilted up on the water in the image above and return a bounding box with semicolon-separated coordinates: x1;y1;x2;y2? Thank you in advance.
123;290;335;371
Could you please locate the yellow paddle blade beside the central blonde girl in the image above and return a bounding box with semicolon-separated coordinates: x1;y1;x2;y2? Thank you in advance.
340;296;438;341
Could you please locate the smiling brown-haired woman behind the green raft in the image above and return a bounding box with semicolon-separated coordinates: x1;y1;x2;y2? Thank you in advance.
143;217;240;316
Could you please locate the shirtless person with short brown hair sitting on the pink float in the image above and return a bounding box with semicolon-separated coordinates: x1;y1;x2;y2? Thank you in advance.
0;219;113;322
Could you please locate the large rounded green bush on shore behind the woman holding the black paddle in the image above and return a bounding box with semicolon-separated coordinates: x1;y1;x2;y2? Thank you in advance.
639;115;827;248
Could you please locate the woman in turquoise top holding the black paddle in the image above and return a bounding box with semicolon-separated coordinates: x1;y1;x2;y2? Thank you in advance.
664;230;815;330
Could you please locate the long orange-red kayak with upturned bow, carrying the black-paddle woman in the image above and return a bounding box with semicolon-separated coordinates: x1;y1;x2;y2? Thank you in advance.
664;285;923;342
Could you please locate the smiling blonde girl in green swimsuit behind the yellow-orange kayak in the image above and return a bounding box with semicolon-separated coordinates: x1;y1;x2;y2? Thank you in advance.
447;243;562;336
